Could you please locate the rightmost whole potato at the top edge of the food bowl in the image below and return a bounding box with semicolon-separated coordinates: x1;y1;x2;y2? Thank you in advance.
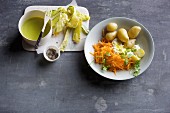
128;26;141;38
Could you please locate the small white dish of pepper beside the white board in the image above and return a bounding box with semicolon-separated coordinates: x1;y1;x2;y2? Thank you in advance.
43;45;60;62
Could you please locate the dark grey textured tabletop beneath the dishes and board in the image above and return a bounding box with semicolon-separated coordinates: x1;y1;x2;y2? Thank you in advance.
0;0;170;113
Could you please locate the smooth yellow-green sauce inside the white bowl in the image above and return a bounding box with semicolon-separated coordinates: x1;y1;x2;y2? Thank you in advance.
21;17;50;41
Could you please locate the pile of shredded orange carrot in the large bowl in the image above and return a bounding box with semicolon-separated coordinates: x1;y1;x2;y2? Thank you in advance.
90;39;132;74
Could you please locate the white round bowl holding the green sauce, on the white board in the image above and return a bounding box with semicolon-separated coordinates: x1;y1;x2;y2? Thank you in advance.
18;10;52;46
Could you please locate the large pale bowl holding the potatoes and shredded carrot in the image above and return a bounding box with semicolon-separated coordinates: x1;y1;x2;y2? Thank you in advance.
84;17;155;80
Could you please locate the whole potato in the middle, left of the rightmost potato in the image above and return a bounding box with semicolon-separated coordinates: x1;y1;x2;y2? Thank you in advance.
117;28;129;42
